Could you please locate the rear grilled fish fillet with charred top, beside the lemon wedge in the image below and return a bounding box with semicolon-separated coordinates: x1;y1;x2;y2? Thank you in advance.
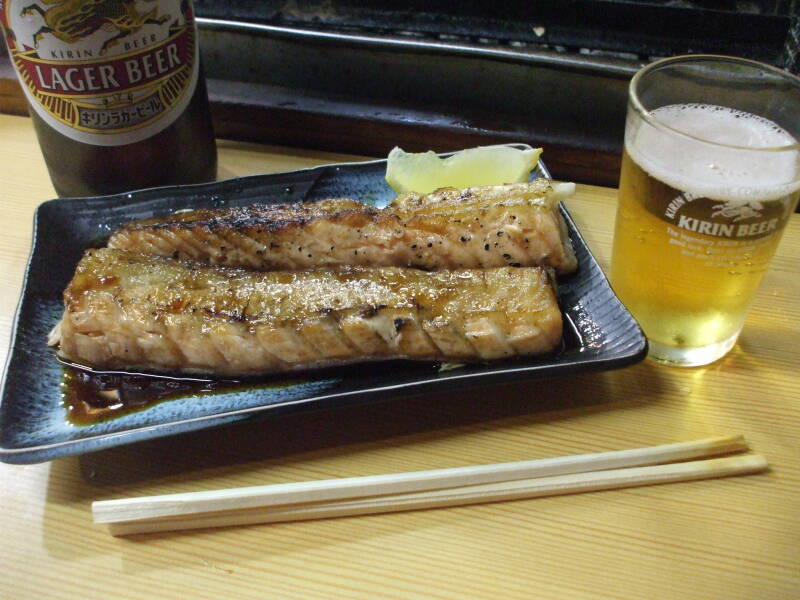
108;179;577;274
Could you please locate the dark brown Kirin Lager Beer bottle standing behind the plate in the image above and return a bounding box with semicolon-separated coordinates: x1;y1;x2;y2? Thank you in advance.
0;0;217;196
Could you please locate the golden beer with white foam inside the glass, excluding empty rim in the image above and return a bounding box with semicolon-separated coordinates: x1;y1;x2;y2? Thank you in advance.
611;104;800;365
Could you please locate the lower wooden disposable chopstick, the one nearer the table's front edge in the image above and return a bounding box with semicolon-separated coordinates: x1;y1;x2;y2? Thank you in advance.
103;455;768;535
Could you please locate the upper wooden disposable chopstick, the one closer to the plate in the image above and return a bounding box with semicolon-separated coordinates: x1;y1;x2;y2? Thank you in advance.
92;435;748;523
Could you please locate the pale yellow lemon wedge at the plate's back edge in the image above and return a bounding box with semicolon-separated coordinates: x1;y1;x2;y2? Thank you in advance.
386;146;542;194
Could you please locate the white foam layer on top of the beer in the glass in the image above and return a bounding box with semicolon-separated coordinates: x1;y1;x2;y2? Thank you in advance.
625;104;800;202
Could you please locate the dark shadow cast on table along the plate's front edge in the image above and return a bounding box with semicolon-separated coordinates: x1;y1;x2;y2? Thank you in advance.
79;364;659;492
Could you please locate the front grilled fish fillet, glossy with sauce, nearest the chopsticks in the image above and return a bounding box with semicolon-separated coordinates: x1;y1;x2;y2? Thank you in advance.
50;248;562;375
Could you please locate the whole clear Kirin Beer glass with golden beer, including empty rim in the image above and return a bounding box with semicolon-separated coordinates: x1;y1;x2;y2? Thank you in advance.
610;55;800;366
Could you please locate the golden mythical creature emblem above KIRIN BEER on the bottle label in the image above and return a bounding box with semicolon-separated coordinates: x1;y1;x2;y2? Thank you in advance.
20;0;170;56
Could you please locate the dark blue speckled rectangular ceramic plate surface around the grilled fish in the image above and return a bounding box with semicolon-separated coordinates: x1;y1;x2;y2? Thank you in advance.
0;145;647;463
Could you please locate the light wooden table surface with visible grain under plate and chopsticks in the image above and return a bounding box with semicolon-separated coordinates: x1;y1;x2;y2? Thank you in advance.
0;116;800;600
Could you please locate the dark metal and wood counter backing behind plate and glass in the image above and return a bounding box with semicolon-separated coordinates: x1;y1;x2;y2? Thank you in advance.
0;0;800;185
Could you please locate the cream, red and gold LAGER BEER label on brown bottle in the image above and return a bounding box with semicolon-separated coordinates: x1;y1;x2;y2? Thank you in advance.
0;0;199;146
